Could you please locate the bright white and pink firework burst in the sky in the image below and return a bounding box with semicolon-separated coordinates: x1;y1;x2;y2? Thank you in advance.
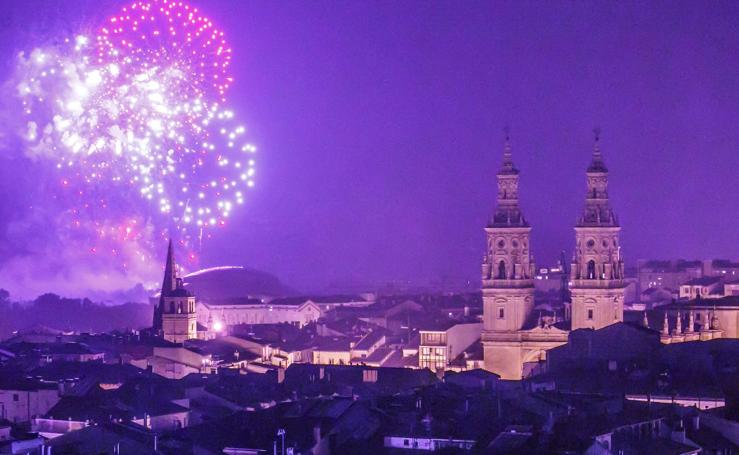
17;0;256;266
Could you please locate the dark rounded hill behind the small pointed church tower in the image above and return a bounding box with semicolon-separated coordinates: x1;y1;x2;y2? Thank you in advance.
183;266;297;300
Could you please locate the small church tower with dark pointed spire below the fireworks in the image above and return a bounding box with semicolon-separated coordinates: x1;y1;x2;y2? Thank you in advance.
153;240;198;343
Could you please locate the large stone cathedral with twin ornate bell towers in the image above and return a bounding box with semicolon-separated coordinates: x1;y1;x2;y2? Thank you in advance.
482;137;625;379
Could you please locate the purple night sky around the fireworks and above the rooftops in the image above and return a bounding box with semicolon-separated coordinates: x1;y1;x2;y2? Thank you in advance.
0;0;739;293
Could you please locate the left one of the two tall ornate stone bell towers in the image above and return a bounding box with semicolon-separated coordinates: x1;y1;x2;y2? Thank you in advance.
482;137;535;377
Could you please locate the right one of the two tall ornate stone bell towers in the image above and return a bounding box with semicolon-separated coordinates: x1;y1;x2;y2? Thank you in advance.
570;135;625;330
